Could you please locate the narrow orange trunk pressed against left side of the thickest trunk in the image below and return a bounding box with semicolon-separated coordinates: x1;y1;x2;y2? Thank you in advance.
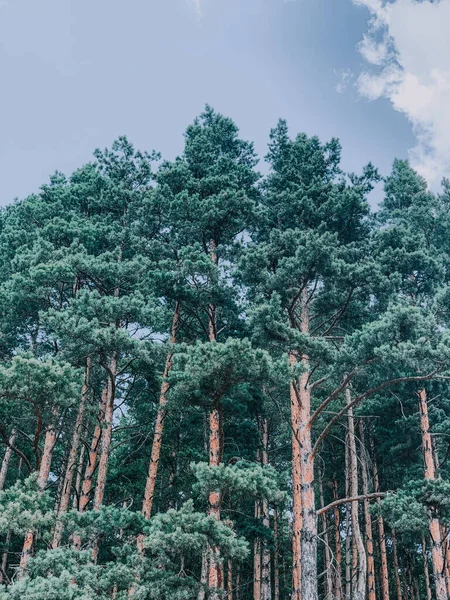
289;353;302;600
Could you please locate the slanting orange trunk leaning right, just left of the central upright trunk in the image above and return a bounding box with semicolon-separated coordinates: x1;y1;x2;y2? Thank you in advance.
142;302;180;519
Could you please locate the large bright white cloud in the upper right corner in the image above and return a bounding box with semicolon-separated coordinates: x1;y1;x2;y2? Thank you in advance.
353;0;450;184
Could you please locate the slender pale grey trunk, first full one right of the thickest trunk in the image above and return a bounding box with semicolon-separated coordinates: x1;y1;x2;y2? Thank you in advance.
346;388;367;600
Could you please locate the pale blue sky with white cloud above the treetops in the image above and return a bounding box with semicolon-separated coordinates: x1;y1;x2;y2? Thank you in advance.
0;0;450;205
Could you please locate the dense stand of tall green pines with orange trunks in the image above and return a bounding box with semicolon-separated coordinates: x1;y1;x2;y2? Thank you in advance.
0;107;450;600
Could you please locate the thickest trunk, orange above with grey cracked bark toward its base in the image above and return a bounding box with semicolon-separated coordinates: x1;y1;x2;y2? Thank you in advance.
298;300;318;600
